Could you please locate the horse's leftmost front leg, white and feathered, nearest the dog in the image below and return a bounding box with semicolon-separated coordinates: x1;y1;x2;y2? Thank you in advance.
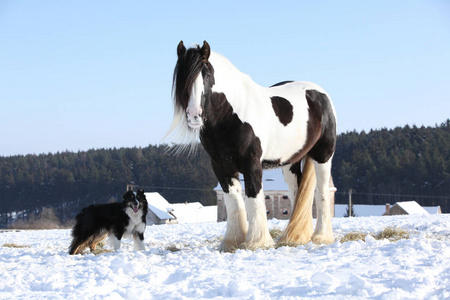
220;178;248;252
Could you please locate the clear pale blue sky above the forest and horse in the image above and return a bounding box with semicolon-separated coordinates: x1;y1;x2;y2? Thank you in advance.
0;0;450;156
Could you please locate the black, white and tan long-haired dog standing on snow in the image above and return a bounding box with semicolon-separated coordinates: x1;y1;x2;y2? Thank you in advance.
69;189;148;255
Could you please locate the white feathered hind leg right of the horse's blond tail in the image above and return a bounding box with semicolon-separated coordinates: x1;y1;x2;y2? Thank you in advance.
312;158;334;244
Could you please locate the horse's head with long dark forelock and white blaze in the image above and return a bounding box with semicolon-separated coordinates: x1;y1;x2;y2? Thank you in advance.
173;41;214;129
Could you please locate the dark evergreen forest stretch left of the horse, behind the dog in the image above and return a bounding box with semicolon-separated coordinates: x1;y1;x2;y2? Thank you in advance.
0;145;217;228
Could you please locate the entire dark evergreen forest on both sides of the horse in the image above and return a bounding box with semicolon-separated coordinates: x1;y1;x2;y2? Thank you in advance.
0;119;450;228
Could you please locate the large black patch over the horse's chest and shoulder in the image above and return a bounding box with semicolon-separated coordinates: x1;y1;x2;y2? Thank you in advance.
200;93;262;198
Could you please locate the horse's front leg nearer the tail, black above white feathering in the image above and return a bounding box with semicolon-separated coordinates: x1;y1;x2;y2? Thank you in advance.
242;169;274;250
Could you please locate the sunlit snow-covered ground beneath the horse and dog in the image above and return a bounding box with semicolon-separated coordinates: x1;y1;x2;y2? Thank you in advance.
0;215;450;300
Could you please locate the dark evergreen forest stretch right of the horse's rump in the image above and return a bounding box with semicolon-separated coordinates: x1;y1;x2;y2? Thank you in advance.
332;120;450;213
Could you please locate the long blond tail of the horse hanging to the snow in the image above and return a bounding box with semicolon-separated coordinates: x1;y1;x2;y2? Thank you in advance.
278;156;316;244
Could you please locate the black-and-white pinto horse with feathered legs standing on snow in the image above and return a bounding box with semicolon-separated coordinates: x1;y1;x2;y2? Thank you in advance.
168;41;337;252
